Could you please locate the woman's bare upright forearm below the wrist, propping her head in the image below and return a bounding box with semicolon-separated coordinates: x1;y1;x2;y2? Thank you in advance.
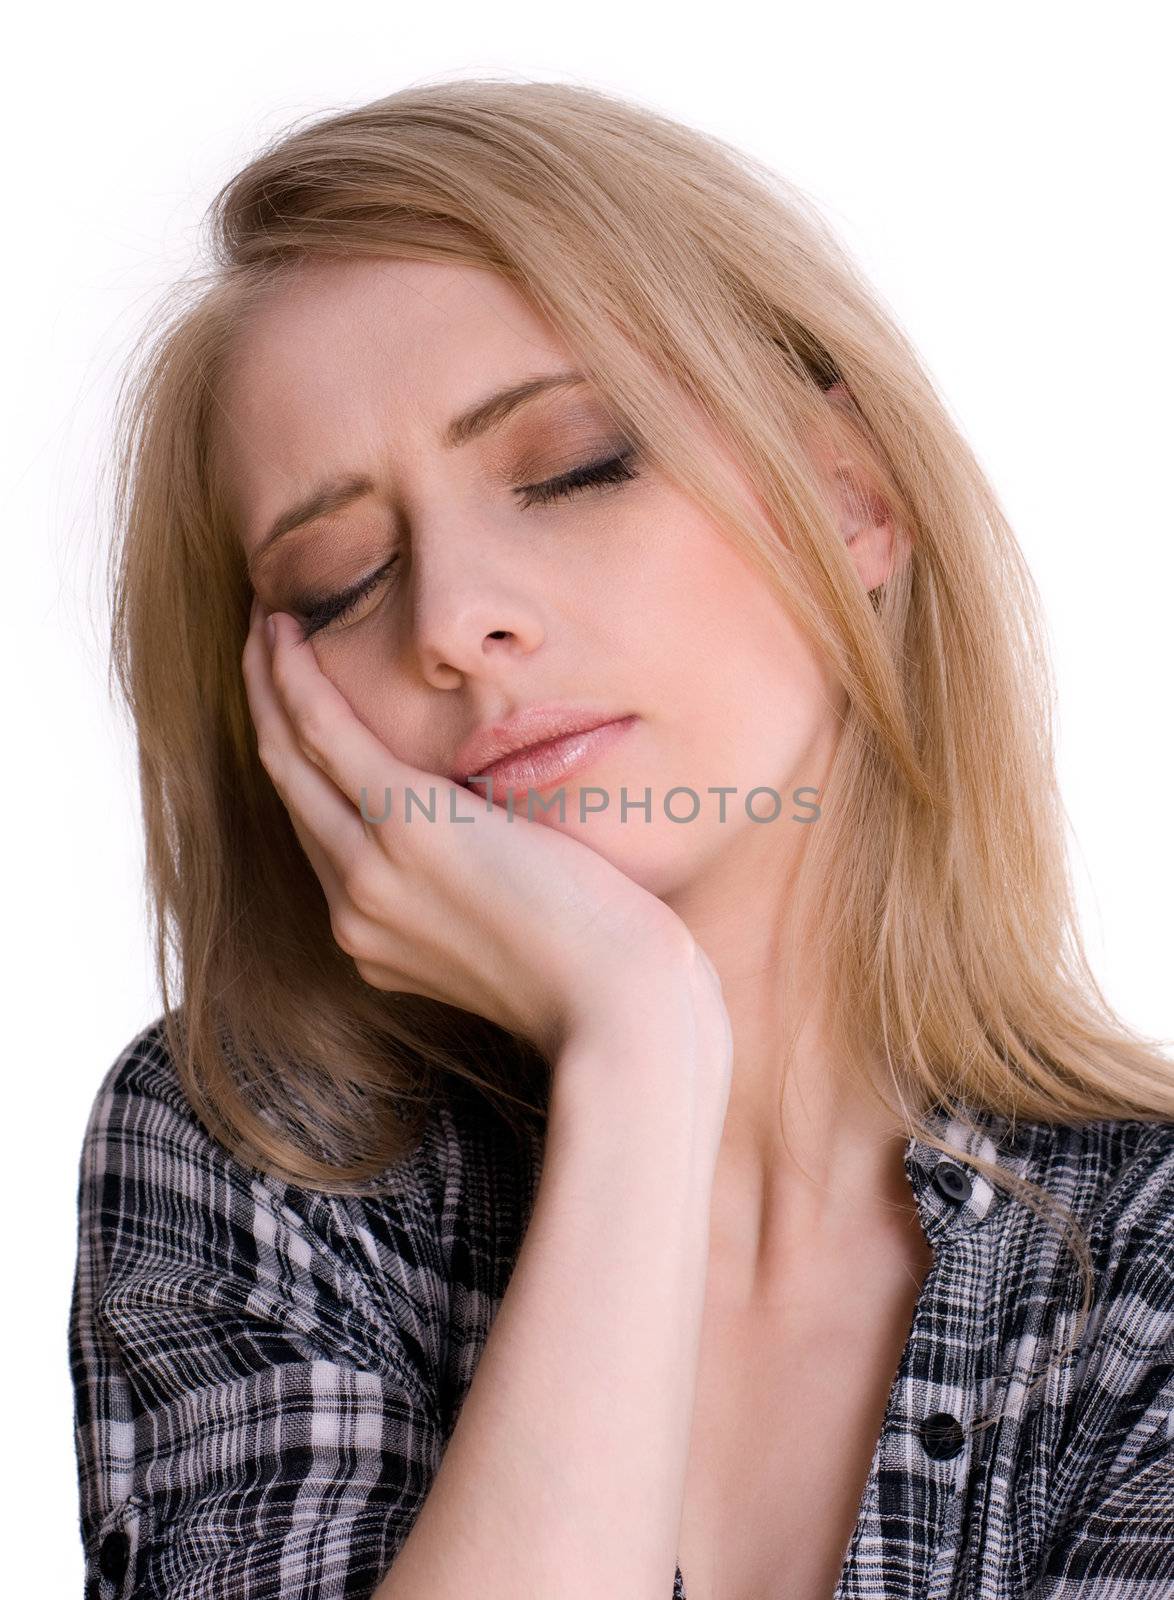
374;1003;725;1600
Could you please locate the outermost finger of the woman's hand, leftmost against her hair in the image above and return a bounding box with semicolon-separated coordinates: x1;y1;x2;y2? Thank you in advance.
242;598;369;904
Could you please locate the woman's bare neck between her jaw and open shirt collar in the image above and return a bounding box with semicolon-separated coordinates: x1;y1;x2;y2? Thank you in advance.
673;812;924;1299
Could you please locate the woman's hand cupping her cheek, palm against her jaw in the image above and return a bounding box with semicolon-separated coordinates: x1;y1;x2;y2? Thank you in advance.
242;600;718;1056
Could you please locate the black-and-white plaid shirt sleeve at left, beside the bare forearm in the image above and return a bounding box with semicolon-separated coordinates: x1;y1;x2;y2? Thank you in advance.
69;1040;454;1600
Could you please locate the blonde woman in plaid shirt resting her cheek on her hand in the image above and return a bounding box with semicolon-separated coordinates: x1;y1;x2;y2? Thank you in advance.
70;80;1174;1600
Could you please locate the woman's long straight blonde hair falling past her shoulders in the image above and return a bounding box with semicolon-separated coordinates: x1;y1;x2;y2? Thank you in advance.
112;78;1174;1427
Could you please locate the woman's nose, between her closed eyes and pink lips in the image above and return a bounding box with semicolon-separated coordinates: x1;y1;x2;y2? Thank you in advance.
409;518;544;688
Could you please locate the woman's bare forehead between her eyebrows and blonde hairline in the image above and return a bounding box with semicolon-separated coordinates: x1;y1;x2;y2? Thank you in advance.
214;259;569;525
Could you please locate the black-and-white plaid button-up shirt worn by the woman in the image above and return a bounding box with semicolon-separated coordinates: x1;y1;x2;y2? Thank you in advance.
69;1021;1174;1600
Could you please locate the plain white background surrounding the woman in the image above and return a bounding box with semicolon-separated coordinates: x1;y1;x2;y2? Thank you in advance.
0;0;1174;1597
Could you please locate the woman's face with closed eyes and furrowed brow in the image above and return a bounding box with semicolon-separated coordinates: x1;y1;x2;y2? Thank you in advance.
218;261;878;898
